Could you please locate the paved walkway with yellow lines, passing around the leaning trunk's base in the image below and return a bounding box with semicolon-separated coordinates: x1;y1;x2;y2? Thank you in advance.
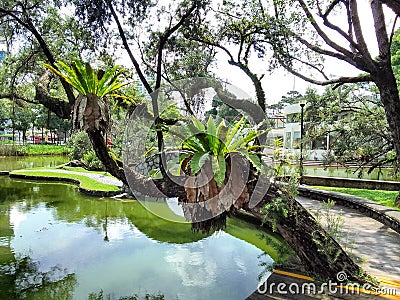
247;196;400;300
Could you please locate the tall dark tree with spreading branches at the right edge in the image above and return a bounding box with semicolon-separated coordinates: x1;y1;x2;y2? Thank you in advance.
274;0;400;169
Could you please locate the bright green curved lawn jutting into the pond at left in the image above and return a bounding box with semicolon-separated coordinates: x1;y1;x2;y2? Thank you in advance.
11;168;119;192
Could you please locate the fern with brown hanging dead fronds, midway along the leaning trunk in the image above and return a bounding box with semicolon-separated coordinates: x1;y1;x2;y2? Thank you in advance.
172;117;265;218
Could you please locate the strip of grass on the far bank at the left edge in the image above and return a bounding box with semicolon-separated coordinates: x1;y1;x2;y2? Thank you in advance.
0;143;71;156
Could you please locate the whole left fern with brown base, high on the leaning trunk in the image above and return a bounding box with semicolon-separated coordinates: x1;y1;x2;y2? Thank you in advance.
44;59;126;133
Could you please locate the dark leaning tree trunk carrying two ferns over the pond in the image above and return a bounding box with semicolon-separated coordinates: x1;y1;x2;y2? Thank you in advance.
87;130;366;281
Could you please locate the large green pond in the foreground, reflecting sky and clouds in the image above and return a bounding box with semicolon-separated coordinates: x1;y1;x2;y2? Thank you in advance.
0;176;273;299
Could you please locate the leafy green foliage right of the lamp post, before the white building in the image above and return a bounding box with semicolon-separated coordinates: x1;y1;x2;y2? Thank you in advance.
305;84;396;170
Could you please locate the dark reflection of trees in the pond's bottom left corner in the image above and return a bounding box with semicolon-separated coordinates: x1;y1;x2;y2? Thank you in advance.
0;256;77;299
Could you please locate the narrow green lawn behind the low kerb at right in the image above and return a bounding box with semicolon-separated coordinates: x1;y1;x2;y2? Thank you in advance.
314;186;400;210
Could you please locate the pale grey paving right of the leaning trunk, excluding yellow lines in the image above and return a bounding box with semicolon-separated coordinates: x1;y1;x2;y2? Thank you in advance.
297;197;400;279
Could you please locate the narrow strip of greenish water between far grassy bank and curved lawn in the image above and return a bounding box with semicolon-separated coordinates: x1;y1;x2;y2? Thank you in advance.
0;156;69;171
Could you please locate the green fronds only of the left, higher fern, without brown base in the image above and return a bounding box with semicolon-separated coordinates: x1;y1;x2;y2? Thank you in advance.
43;59;127;97
